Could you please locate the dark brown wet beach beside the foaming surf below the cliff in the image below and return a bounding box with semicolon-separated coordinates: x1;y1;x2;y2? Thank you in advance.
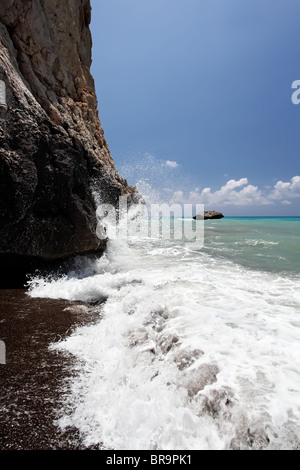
0;289;99;450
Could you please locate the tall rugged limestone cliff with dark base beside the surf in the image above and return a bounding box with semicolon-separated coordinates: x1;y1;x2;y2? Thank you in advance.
0;0;132;259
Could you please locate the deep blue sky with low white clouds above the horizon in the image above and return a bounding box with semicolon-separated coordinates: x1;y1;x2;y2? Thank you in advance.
92;0;300;216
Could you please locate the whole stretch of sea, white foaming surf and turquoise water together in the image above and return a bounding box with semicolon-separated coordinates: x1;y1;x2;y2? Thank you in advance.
30;218;300;450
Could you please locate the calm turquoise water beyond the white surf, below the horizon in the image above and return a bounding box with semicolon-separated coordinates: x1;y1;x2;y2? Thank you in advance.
204;217;300;275
